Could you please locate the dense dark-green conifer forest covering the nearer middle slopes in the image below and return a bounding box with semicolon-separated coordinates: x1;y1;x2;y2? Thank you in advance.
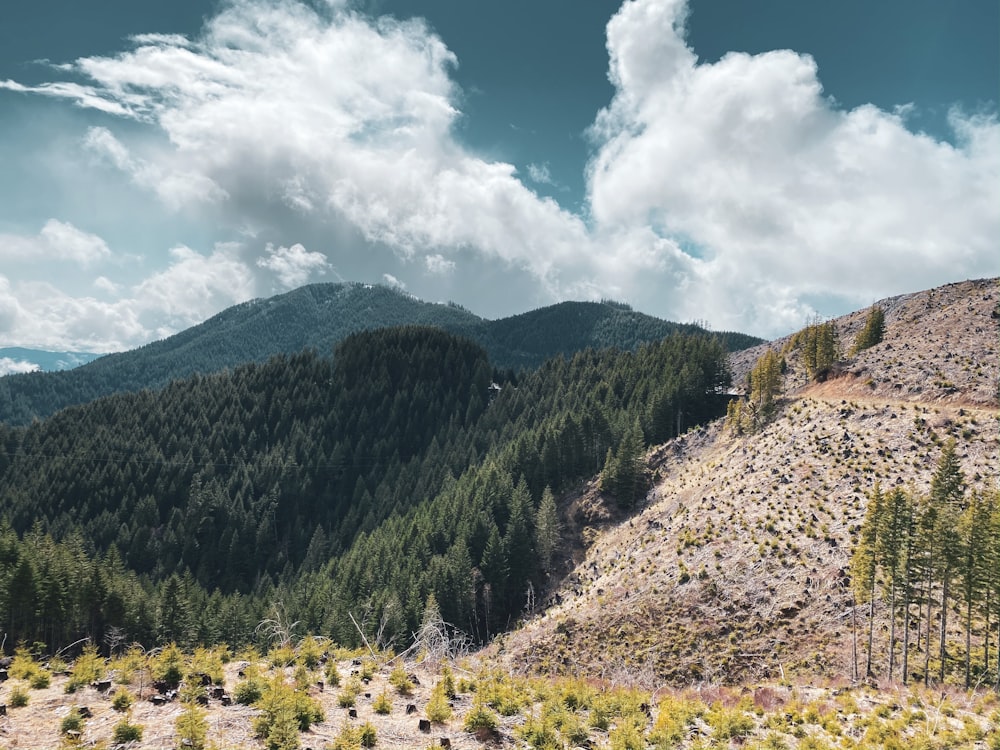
0;328;729;645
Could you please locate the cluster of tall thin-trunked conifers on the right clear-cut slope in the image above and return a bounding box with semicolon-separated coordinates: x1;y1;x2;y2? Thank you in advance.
851;441;1000;689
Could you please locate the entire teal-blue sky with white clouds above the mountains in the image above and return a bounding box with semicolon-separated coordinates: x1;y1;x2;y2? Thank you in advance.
0;0;1000;362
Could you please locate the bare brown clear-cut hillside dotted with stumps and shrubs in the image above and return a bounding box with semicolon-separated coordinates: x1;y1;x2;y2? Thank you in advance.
496;280;1000;683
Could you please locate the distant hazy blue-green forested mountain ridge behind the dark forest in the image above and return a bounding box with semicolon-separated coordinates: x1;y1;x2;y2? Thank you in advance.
0;284;760;425
